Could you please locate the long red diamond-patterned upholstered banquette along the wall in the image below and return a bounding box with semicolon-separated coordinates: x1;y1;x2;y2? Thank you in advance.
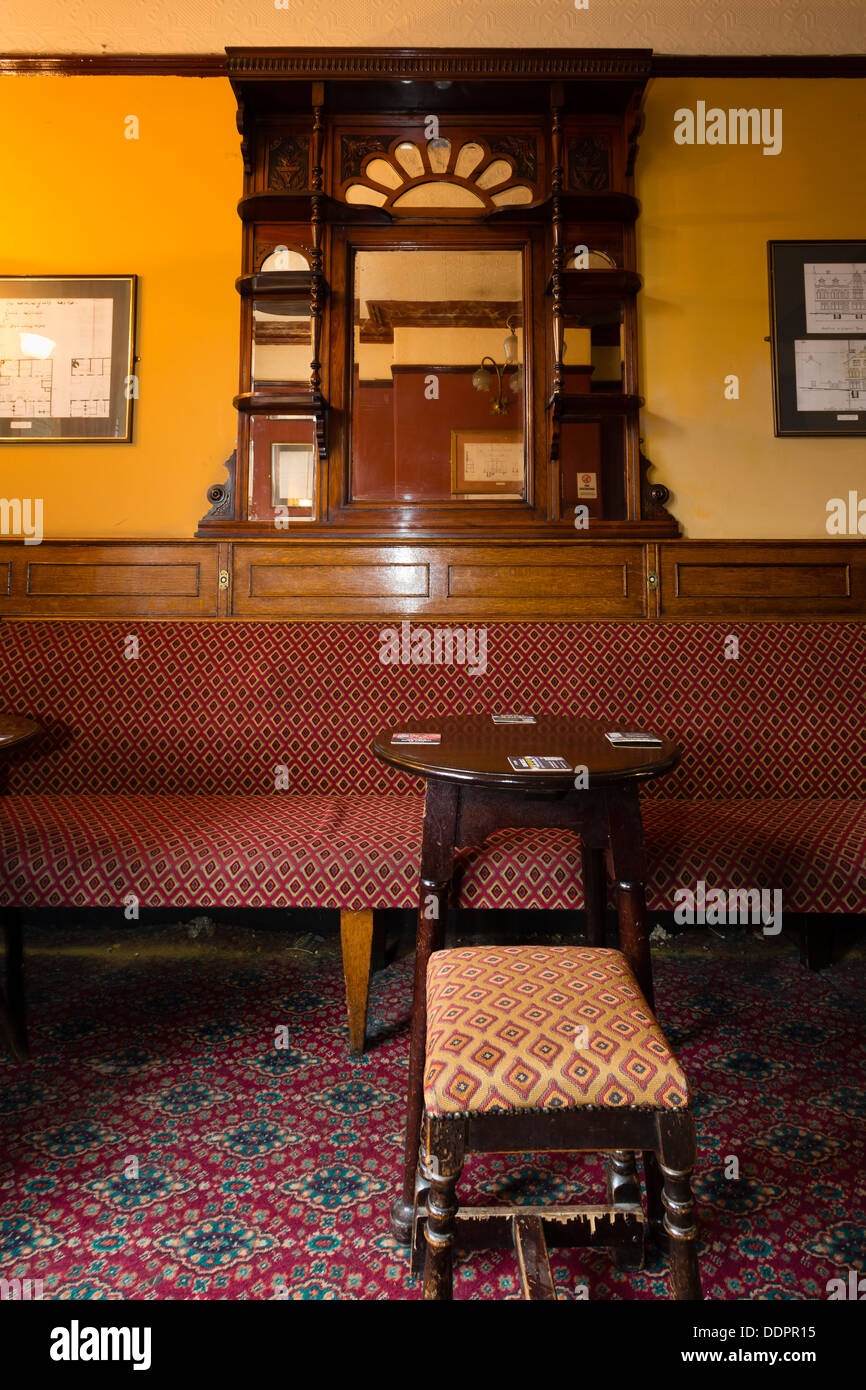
0;620;866;1034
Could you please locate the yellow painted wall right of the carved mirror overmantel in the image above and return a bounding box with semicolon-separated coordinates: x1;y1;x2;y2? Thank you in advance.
637;79;866;538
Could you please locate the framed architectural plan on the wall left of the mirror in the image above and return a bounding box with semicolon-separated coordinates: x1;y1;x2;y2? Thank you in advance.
0;275;138;443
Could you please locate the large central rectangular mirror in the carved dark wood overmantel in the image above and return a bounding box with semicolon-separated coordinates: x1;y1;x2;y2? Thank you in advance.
352;247;527;503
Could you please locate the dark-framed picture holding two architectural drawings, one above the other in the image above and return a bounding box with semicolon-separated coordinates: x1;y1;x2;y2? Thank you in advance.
767;240;866;435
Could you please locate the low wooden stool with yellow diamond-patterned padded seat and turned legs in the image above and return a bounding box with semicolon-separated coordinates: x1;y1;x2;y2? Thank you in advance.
413;947;701;1298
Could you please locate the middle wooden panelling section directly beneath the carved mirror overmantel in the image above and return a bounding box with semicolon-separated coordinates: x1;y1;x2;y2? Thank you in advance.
232;541;646;620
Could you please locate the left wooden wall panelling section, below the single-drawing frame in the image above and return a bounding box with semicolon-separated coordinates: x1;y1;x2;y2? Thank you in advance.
0;541;220;619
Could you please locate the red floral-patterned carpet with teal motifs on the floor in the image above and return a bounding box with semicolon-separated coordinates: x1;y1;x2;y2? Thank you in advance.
0;924;866;1300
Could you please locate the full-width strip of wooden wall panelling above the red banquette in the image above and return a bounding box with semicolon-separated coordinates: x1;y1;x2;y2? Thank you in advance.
0;538;866;621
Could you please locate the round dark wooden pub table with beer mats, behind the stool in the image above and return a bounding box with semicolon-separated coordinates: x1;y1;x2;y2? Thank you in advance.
373;714;680;1244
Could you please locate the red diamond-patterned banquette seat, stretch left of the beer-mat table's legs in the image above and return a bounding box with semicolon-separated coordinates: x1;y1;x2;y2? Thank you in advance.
0;792;424;912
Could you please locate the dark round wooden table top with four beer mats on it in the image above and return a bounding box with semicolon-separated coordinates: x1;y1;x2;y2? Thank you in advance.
373;714;680;792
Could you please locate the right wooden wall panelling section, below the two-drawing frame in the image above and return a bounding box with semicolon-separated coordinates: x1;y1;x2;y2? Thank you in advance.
659;539;866;620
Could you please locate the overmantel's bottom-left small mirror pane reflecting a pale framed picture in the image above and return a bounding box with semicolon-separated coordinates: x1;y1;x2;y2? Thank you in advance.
247;416;317;531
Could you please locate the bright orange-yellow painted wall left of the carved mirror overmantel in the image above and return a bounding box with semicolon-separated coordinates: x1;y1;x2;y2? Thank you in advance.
0;76;243;538
